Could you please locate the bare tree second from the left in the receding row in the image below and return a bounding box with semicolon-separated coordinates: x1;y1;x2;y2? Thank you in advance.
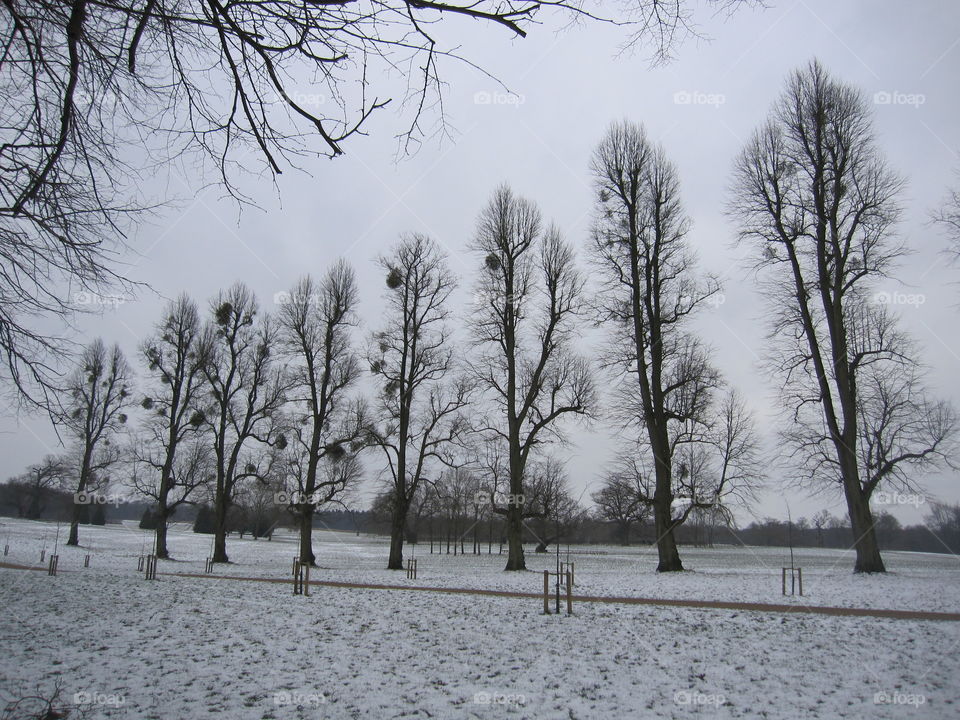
135;295;209;558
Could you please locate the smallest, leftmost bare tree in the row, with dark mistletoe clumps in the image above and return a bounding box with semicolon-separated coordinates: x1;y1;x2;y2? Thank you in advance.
56;338;130;545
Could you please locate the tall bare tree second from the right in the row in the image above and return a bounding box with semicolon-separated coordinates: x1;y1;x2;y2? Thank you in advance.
591;122;721;572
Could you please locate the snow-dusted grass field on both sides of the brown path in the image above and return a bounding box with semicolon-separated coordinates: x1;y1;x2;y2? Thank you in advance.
0;519;960;720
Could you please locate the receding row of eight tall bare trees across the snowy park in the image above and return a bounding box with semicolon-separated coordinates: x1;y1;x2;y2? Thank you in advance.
11;62;955;572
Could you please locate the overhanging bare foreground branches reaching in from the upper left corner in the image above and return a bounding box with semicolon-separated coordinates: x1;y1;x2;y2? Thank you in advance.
0;0;720;402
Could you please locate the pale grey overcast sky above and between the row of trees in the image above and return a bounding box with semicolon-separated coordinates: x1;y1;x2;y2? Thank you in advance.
0;0;960;522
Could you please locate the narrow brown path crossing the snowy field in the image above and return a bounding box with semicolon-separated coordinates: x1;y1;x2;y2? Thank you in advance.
0;562;960;622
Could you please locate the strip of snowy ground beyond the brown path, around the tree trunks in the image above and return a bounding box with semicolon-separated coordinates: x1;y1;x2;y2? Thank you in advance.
0;519;960;612
